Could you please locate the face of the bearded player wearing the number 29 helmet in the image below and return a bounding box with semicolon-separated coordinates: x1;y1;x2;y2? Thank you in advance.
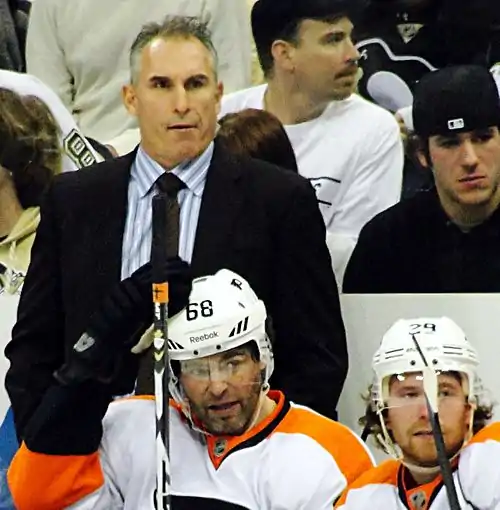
387;373;471;467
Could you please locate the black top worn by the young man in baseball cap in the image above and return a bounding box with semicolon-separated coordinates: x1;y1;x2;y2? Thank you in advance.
343;189;500;294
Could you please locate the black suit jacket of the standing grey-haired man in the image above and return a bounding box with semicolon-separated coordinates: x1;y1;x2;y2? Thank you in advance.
5;143;347;437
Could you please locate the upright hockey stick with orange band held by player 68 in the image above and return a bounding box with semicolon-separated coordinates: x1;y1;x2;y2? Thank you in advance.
151;193;171;510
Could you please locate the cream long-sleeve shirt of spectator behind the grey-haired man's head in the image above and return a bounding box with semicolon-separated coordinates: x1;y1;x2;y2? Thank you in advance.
26;0;251;152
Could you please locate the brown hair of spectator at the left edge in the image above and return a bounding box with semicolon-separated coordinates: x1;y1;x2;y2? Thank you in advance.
0;88;62;209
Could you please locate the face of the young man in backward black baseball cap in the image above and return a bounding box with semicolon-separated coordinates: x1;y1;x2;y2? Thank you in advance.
419;127;500;214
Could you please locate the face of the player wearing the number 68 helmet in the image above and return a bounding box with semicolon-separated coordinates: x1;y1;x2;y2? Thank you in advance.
180;347;263;436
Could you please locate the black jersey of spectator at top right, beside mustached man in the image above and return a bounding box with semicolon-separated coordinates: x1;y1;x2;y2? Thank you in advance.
355;0;500;107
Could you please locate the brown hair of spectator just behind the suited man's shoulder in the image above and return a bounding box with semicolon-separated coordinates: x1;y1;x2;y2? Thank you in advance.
217;108;298;172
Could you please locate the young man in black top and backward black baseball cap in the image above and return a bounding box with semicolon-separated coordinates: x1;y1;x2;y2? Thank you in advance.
344;65;500;293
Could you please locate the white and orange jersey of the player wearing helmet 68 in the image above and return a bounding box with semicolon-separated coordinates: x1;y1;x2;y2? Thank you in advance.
8;392;373;510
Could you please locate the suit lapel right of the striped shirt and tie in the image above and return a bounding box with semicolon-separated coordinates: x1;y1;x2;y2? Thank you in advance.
191;142;244;275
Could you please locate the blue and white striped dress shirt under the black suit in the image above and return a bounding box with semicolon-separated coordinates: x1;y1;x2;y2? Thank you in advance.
121;142;214;279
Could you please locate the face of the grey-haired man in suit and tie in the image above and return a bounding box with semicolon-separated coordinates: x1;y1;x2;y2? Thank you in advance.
123;37;222;168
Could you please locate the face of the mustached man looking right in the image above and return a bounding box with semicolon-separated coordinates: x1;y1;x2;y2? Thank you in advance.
291;18;359;103
